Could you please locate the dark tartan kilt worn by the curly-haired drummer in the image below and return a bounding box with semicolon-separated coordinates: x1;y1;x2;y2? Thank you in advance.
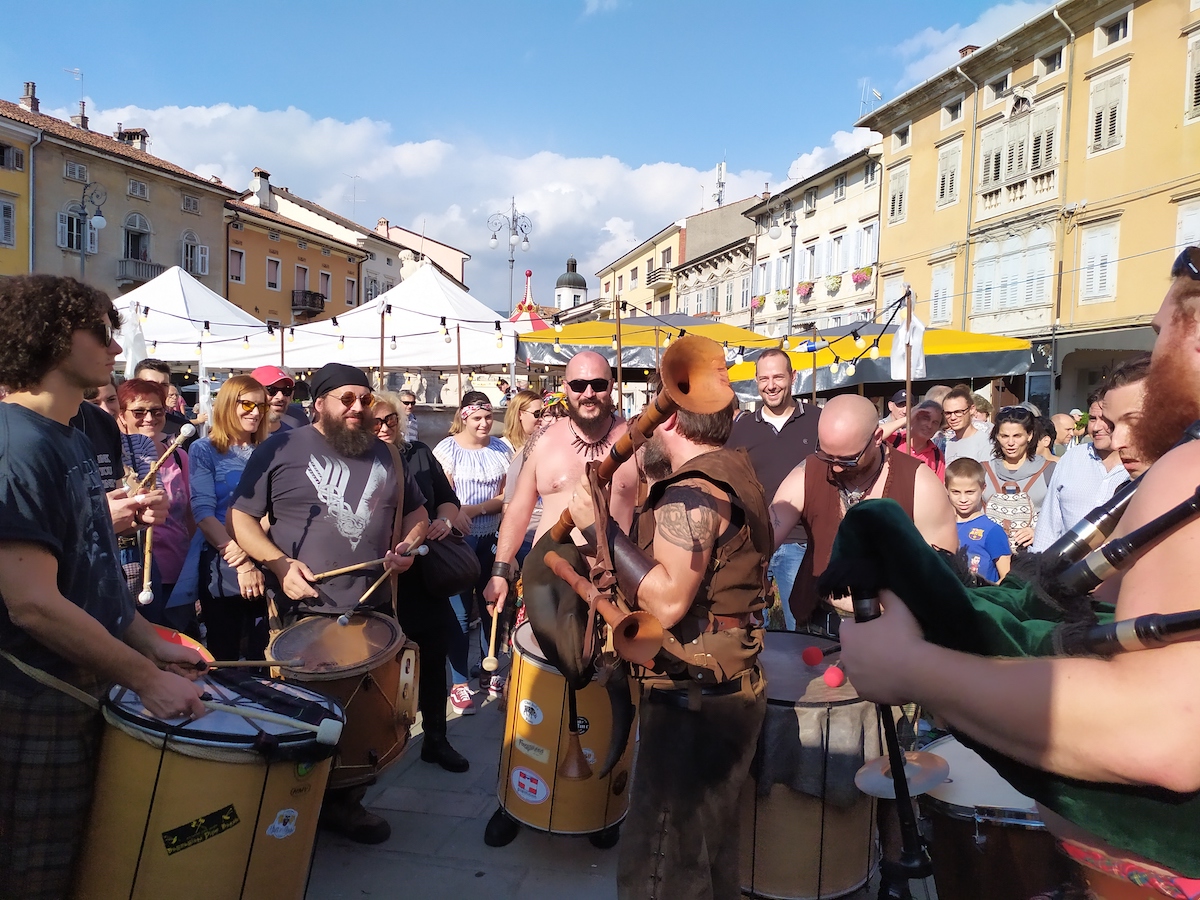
0;664;106;900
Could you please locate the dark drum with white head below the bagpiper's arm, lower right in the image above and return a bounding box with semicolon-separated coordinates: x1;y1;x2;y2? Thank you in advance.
918;736;1070;900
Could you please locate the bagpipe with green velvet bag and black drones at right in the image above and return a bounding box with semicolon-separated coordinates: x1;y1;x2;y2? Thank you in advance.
818;422;1200;876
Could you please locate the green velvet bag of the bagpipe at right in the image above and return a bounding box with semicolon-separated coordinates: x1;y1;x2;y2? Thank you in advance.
820;500;1200;877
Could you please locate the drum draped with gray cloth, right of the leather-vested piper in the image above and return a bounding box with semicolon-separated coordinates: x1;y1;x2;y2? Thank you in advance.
740;631;882;898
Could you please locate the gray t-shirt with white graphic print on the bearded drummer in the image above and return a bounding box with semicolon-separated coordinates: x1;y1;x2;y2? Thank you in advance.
230;425;425;613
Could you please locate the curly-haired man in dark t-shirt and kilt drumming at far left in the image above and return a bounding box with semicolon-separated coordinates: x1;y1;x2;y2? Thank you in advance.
0;275;205;900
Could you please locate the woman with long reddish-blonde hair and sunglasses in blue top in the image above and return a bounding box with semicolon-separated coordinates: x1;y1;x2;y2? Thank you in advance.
170;376;268;659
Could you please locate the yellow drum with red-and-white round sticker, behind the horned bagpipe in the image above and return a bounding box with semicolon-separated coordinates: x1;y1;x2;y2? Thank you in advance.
496;622;636;834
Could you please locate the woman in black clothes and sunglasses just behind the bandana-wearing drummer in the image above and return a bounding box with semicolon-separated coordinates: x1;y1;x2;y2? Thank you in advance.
371;391;470;772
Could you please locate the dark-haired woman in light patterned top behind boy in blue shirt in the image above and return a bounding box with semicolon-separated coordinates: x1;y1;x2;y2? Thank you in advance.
983;407;1055;553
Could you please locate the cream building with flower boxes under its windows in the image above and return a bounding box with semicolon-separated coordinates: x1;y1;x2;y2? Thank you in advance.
745;145;882;337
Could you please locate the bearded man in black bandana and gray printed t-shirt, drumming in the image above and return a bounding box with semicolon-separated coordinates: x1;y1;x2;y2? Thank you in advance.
226;362;430;844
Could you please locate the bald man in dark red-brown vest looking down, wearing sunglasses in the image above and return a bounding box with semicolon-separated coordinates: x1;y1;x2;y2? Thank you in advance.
770;394;959;634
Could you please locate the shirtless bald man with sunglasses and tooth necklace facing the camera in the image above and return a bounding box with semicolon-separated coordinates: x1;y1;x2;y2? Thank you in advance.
484;350;637;612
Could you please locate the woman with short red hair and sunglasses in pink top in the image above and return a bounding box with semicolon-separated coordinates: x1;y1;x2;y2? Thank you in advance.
116;378;196;634
